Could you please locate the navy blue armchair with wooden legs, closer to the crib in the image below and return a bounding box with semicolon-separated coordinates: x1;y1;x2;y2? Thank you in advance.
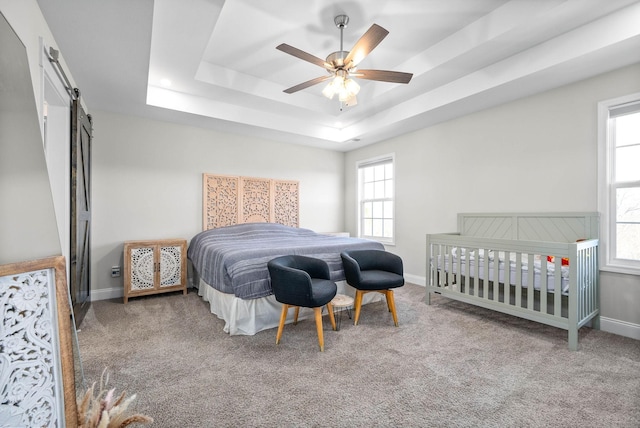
340;250;404;327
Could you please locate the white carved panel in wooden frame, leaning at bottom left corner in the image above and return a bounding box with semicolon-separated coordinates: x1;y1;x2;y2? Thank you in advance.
0;256;77;427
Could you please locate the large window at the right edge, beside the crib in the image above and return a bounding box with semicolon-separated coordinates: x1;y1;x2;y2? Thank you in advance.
598;93;640;275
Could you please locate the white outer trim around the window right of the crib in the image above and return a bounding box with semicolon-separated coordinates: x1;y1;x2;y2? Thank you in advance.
597;92;640;275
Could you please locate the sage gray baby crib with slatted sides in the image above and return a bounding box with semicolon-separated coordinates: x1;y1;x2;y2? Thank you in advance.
425;213;600;351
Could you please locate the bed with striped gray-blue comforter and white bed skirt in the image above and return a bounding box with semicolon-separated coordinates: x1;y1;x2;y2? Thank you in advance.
187;223;384;335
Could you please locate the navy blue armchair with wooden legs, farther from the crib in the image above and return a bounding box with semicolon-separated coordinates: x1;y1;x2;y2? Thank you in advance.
267;255;338;351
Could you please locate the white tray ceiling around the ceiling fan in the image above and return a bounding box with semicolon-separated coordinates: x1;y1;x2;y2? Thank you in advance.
38;0;640;151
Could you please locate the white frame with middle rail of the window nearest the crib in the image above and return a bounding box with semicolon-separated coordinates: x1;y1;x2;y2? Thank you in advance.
598;92;640;275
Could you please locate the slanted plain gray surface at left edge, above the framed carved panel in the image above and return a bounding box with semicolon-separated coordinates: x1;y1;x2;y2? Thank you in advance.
0;10;61;264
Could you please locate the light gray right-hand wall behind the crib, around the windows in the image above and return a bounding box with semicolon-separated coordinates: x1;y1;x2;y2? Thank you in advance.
345;65;640;332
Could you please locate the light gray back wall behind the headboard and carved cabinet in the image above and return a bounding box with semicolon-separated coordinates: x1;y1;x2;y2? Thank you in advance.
91;110;344;299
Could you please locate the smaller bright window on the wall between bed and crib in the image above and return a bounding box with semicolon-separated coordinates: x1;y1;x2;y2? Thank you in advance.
358;155;395;244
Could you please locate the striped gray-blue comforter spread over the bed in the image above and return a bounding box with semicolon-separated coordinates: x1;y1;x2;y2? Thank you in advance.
187;223;384;299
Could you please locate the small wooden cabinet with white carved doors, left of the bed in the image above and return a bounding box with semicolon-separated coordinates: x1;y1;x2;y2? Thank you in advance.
124;239;187;303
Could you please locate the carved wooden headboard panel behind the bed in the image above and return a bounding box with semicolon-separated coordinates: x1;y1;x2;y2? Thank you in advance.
202;174;300;230
